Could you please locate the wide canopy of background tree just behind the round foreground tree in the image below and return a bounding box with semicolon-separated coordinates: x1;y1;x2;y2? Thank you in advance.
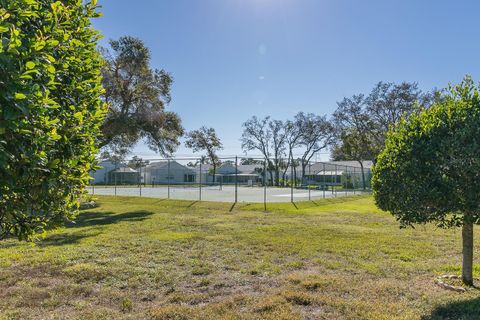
332;82;437;164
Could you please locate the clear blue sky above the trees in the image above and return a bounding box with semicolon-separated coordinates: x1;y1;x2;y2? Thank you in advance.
93;0;480;158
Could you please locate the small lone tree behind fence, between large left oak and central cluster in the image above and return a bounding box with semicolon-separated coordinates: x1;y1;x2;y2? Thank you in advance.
185;126;223;184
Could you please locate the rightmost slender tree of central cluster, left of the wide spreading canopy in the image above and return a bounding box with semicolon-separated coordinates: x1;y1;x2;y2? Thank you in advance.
297;113;334;179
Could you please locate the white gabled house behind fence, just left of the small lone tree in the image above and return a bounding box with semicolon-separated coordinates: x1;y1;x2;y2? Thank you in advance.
143;160;195;184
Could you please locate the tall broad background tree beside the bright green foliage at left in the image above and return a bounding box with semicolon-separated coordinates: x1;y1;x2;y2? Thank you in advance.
101;36;183;156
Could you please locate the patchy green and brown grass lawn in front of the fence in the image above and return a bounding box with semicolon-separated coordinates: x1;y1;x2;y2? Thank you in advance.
0;196;480;320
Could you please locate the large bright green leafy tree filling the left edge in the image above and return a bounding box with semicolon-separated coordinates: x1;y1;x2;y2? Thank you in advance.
0;0;106;240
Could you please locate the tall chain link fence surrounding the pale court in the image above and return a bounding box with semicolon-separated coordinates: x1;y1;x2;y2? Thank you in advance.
88;157;372;204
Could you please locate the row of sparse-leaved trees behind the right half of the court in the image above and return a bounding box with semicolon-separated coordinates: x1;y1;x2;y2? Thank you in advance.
241;82;441;186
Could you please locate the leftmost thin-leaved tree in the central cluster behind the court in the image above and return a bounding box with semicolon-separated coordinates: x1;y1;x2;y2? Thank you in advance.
241;116;273;183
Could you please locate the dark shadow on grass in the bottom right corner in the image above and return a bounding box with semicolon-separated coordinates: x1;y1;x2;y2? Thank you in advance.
422;298;480;320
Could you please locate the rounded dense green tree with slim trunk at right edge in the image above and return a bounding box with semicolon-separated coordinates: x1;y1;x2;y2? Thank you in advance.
372;77;480;285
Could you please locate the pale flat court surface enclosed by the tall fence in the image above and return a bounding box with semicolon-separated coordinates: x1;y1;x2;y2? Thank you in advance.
88;185;361;202
